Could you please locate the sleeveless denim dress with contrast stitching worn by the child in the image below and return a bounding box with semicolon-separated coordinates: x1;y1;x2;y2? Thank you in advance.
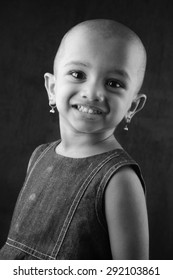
0;141;145;260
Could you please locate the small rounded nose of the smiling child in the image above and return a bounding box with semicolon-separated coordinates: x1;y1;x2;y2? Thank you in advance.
81;82;105;102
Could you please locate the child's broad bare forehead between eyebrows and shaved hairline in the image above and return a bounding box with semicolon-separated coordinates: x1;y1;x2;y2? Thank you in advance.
57;28;141;71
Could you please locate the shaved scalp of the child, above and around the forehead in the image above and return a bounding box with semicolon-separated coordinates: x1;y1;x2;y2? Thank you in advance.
54;19;147;94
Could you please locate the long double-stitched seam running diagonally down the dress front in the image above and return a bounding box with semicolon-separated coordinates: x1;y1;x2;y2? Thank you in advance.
51;152;119;257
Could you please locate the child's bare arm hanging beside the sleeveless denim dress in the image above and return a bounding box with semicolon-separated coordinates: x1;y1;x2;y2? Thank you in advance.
105;167;149;260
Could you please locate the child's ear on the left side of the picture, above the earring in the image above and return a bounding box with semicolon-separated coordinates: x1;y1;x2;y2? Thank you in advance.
44;73;56;105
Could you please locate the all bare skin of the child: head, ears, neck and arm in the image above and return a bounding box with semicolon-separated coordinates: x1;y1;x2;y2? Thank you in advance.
45;20;148;259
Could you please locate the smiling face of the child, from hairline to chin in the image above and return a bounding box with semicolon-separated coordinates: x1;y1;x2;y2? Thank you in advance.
45;27;145;133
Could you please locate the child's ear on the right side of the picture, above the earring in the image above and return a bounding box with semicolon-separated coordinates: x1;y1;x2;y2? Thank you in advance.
127;94;147;119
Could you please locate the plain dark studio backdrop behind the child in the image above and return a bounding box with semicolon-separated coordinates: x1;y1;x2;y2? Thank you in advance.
0;0;173;259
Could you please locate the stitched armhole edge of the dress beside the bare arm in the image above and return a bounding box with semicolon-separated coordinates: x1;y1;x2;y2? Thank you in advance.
95;159;135;231
